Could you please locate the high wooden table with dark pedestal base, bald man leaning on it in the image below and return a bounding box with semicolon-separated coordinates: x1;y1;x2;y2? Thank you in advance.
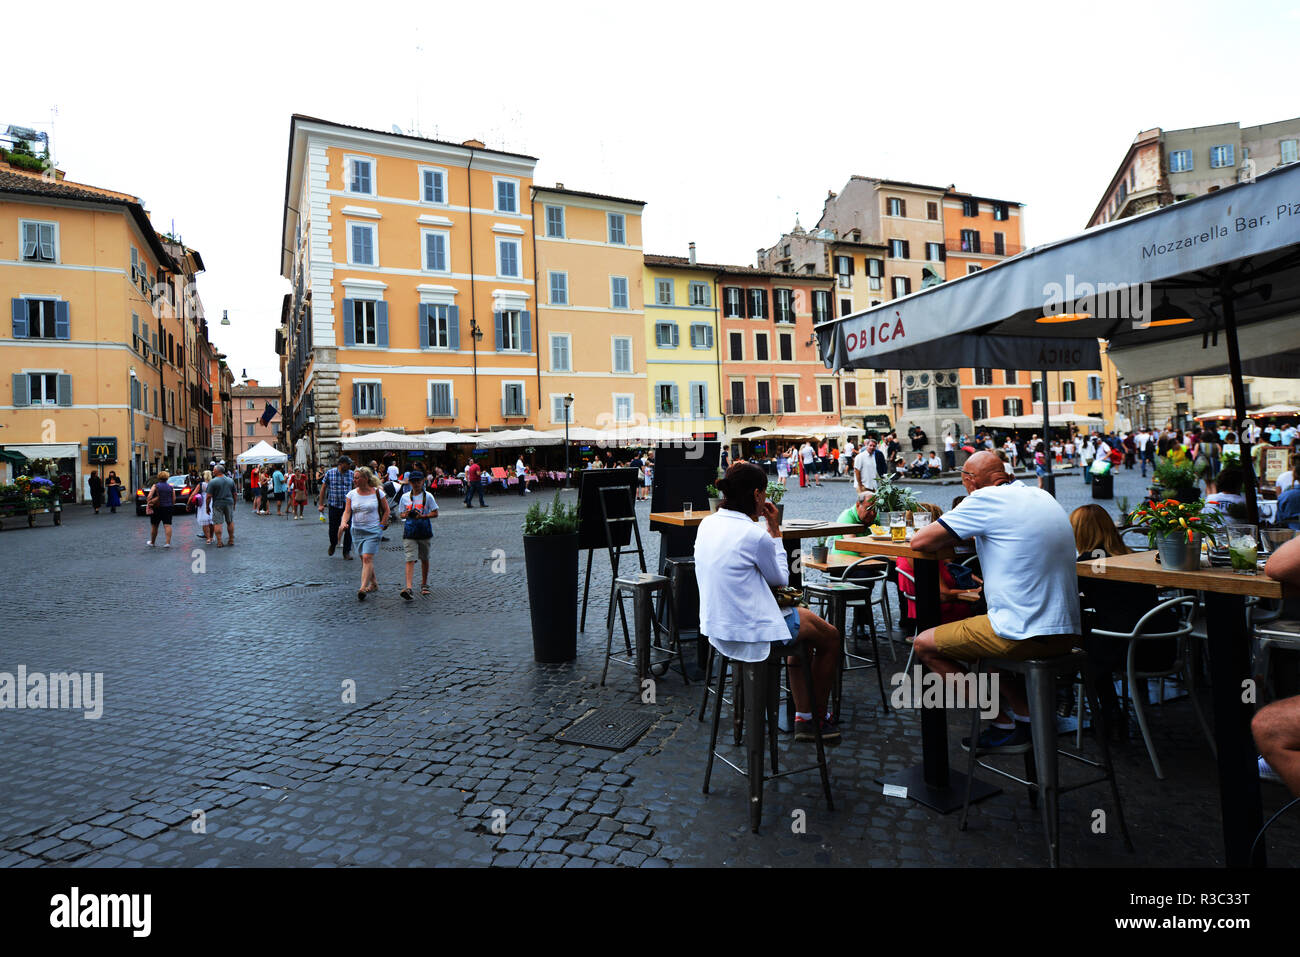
836;527;998;814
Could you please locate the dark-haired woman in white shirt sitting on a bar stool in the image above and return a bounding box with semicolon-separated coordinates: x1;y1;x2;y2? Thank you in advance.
696;462;840;744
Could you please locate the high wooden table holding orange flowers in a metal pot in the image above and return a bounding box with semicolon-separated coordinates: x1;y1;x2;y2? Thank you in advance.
1078;551;1300;867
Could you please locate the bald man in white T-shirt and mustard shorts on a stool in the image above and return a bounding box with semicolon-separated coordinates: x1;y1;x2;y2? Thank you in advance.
911;452;1080;754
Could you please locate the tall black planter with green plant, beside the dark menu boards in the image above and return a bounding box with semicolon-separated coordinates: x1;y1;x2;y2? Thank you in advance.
524;492;579;663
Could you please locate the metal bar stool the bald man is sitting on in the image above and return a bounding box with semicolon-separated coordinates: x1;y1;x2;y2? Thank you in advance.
959;648;1134;867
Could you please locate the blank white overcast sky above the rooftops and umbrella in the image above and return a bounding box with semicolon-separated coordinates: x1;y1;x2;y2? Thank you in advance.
10;0;1300;382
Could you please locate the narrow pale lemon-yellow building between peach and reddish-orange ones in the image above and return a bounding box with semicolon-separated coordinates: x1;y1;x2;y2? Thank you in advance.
644;250;724;437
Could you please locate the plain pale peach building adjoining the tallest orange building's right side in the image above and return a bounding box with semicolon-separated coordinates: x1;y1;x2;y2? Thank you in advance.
532;183;649;429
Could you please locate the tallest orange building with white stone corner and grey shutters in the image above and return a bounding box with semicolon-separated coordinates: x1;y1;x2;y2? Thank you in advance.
281;114;549;460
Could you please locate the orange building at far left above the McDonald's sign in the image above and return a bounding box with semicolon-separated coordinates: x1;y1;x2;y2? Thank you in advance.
0;164;198;501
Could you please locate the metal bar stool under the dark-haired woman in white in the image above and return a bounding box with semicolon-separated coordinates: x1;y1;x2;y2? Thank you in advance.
703;641;835;833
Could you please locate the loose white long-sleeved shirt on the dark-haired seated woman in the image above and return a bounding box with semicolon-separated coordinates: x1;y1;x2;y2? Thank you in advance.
696;508;790;662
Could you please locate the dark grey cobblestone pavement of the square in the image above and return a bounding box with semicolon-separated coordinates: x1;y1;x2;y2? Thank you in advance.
0;472;1300;867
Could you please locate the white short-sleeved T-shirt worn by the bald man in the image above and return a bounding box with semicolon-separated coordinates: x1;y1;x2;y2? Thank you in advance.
939;482;1080;641
